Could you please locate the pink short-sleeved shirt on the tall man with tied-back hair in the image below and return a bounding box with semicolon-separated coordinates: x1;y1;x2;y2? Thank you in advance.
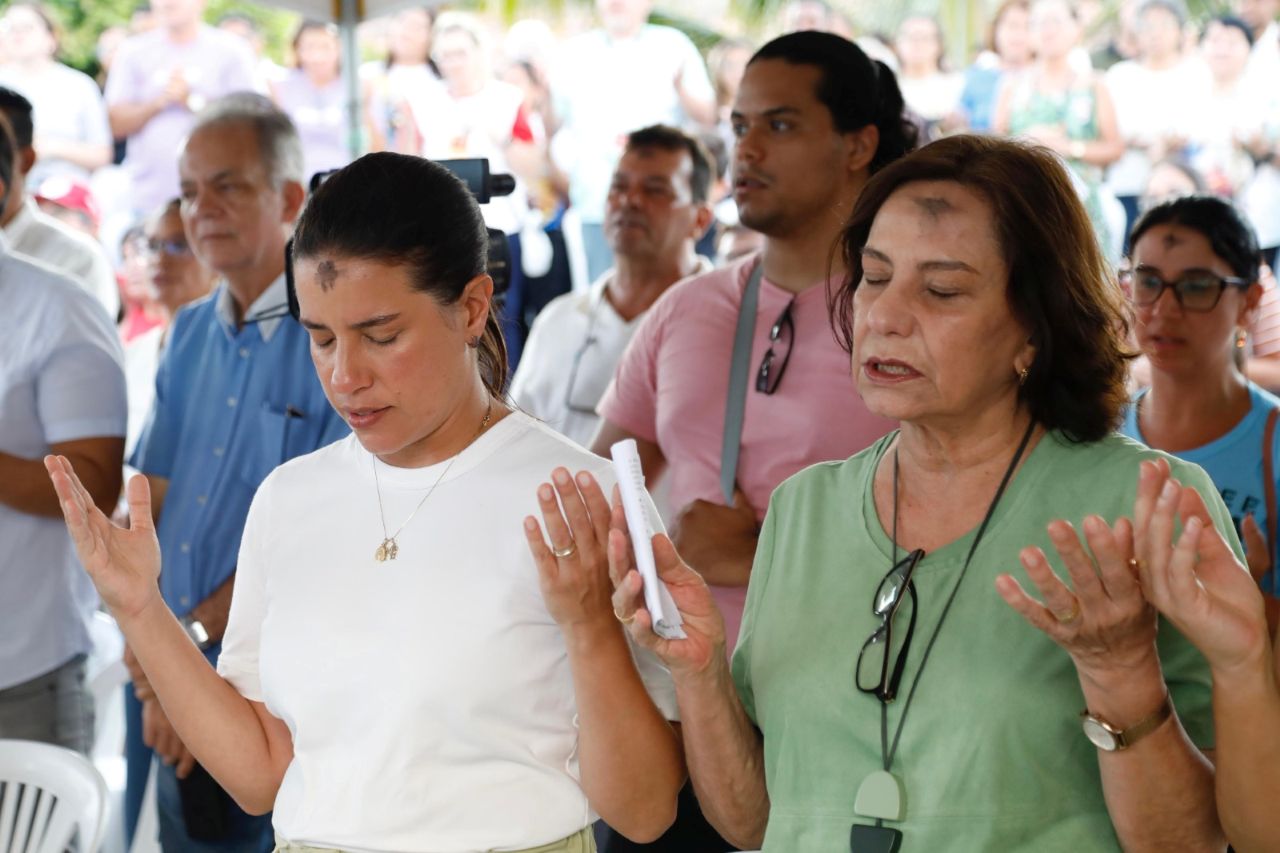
599;249;897;652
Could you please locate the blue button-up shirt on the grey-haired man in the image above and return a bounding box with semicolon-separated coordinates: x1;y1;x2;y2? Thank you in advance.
131;275;349;630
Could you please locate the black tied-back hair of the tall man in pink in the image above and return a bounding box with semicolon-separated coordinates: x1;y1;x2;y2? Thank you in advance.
748;29;919;174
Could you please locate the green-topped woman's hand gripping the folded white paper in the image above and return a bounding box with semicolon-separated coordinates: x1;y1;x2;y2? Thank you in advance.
608;489;724;679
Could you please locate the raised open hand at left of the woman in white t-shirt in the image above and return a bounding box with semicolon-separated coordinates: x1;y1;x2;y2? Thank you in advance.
45;456;160;622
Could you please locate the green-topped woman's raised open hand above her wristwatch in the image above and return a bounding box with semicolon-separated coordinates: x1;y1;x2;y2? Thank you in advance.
996;515;1156;676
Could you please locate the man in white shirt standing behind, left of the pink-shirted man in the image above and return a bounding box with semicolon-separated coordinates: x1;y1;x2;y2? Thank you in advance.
511;124;712;447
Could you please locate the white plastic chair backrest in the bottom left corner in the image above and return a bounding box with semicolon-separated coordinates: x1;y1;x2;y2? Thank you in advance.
0;740;106;853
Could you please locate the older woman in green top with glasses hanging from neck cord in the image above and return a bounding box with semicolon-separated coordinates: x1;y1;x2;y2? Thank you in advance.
611;136;1238;853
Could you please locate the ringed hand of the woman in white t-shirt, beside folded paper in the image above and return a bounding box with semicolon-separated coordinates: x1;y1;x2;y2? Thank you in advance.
525;467;617;629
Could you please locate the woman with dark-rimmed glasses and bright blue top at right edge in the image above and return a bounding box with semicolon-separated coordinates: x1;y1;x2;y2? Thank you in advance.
1121;196;1280;626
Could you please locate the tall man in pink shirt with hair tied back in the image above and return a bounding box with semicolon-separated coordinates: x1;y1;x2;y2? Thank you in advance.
591;32;915;652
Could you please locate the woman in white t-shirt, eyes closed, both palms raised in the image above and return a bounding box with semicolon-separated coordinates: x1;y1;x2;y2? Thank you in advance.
49;154;685;853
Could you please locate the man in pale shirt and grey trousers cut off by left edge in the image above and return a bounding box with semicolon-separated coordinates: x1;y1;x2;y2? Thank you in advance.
0;111;125;753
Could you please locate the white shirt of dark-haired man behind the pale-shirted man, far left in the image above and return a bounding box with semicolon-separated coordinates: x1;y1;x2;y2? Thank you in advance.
4;196;120;323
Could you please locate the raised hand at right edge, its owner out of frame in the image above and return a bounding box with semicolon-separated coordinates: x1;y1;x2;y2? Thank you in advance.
1135;462;1270;671
